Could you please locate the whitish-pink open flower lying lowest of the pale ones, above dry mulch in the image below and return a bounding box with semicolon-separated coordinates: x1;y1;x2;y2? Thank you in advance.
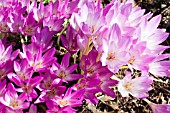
118;73;153;98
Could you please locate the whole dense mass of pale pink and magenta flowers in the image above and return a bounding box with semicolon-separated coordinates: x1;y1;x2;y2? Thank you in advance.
0;0;170;113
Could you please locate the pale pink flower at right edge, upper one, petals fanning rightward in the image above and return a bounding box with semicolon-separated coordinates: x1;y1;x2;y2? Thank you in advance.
137;15;169;54
